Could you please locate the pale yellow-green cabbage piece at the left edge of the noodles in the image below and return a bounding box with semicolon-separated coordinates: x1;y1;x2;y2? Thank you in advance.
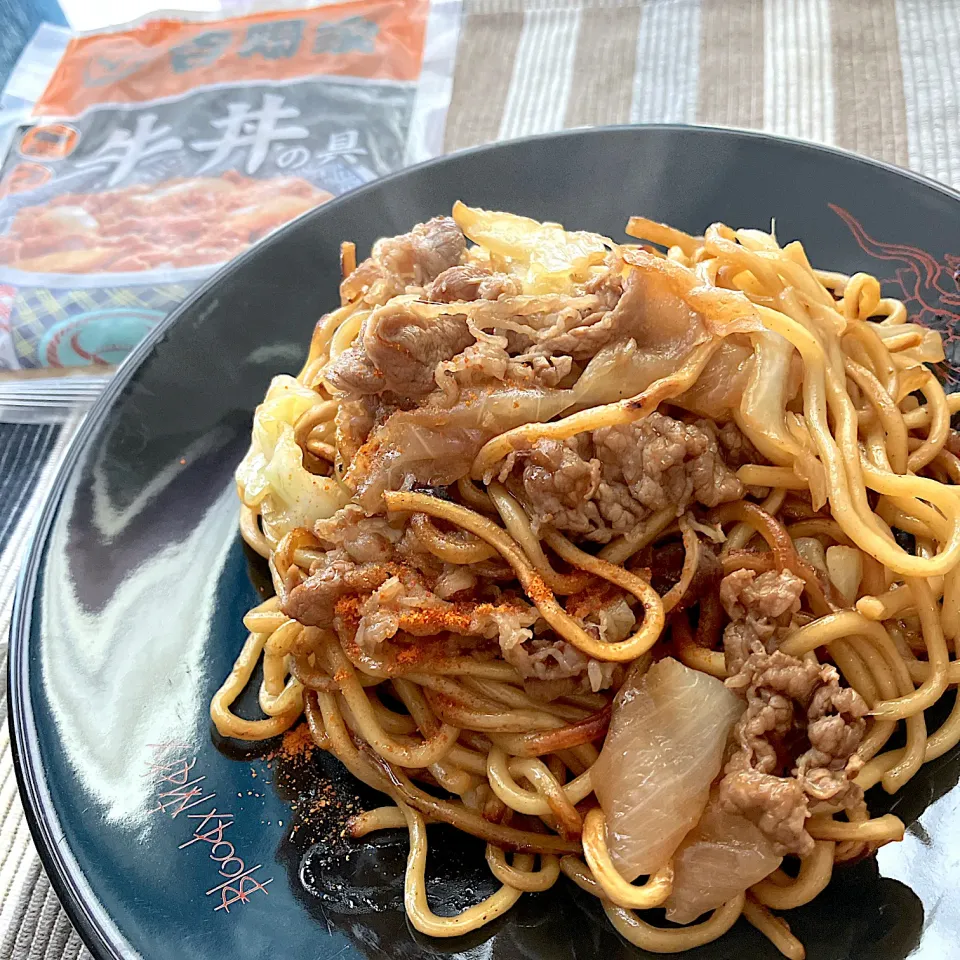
236;375;350;539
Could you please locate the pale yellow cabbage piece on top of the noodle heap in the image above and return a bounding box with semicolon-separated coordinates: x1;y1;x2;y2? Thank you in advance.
453;201;613;294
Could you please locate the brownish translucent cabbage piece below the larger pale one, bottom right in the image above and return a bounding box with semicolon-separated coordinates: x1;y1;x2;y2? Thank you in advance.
664;794;783;923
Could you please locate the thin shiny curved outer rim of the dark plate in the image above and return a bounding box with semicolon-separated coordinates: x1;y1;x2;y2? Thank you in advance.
6;123;960;960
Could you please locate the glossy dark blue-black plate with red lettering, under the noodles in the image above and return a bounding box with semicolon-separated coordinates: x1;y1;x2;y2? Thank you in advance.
10;127;960;960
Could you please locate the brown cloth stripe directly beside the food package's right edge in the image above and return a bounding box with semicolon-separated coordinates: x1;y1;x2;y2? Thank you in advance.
444;13;523;152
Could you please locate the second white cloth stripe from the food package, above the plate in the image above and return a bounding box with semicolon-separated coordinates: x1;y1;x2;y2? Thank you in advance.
630;0;700;123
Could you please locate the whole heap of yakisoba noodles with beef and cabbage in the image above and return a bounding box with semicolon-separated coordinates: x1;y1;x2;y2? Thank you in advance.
211;204;960;957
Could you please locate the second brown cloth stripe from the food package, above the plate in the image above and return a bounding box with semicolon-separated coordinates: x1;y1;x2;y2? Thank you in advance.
565;5;640;127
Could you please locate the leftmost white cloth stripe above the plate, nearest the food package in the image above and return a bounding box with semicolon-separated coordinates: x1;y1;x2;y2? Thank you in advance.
499;4;581;140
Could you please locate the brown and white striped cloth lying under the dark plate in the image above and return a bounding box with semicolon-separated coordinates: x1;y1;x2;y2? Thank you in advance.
0;0;960;960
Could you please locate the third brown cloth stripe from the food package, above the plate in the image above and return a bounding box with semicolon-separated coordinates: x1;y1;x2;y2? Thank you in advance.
697;0;763;127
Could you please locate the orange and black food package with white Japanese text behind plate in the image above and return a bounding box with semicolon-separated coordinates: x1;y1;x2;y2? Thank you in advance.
0;0;459;372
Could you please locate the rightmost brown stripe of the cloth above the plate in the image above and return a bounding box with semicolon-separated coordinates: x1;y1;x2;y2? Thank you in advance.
830;0;909;166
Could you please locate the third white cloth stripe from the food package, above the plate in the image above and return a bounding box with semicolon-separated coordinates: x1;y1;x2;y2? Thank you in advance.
763;0;832;143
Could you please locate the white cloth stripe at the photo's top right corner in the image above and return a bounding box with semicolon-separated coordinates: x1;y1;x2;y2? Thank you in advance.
896;0;960;187
